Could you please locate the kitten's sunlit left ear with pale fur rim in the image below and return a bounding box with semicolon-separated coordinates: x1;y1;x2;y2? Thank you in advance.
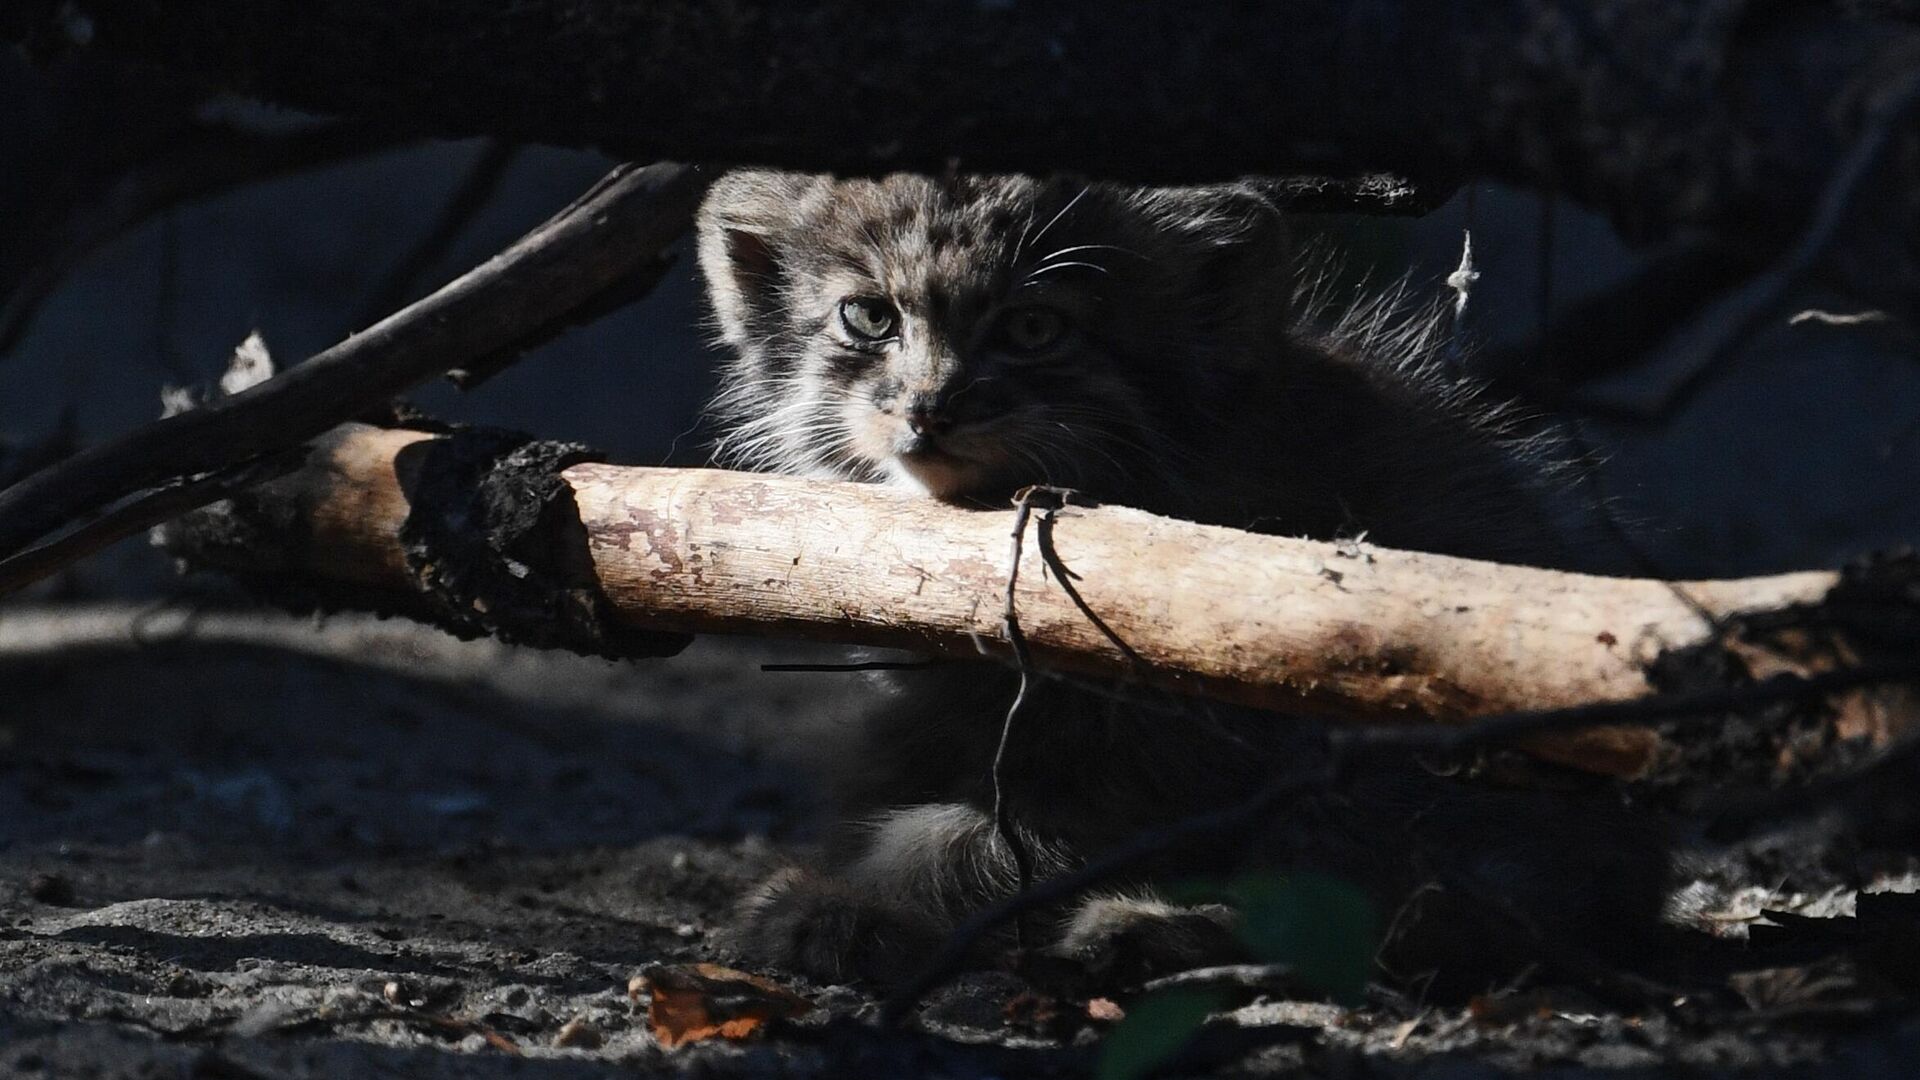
695;169;818;346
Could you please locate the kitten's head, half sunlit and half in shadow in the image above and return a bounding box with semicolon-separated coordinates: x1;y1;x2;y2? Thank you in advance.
699;171;1288;498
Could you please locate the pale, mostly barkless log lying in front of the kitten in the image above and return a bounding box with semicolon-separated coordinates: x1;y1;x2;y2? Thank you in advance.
165;425;1904;774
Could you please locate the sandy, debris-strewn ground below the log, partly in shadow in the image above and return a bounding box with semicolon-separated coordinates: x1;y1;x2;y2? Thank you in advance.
0;605;1920;1078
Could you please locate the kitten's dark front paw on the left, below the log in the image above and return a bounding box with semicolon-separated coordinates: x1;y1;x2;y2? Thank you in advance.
733;867;945;986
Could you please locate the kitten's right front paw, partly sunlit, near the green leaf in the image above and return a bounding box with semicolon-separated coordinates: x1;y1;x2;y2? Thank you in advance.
1054;896;1244;986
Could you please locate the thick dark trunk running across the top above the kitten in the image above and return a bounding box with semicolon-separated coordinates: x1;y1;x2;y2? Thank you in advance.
0;0;1920;242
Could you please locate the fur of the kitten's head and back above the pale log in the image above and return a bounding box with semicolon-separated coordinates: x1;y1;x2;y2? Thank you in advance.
699;171;1572;565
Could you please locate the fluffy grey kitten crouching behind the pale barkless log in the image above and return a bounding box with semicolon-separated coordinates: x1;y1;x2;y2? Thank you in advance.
699;171;1628;980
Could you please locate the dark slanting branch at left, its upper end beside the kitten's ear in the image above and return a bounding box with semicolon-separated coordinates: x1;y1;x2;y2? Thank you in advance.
0;165;705;555
